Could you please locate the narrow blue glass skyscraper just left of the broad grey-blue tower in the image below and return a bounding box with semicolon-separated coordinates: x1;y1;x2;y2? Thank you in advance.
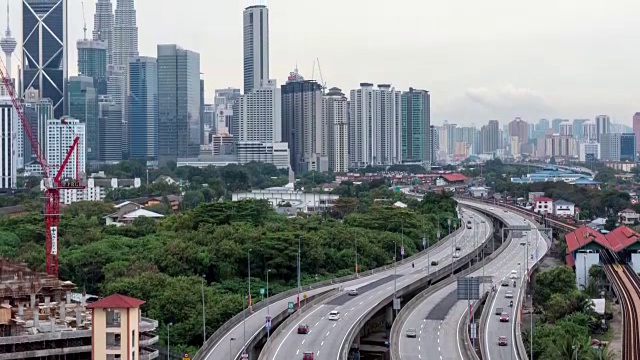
129;56;158;160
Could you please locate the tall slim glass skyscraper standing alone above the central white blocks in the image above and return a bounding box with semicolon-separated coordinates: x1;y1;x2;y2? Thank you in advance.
243;5;269;94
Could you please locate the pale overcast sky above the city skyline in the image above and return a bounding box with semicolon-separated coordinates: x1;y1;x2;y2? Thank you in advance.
7;0;640;125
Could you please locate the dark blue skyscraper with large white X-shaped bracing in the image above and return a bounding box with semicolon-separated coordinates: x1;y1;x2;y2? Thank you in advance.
22;0;68;118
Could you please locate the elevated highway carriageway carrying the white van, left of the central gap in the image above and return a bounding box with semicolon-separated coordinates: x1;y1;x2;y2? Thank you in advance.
261;209;490;360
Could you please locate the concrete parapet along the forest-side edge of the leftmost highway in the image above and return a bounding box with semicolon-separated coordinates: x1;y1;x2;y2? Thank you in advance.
193;221;462;360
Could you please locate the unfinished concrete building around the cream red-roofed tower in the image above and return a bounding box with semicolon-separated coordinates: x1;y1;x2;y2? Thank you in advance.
0;259;158;360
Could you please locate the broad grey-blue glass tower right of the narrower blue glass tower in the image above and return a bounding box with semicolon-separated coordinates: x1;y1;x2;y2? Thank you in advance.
157;44;201;163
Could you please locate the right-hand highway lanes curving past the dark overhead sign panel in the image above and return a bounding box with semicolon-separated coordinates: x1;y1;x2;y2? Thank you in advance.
392;201;547;360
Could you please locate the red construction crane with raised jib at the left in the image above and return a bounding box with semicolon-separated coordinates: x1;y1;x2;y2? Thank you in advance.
0;58;84;277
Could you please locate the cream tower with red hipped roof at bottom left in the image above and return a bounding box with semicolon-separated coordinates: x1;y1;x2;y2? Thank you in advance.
87;294;144;360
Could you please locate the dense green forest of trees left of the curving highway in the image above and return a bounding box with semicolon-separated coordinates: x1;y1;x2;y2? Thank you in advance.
0;166;456;351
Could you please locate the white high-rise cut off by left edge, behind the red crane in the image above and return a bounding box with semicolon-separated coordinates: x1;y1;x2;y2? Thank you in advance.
0;98;16;192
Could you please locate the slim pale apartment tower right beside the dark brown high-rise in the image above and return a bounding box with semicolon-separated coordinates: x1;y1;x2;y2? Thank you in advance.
322;87;349;173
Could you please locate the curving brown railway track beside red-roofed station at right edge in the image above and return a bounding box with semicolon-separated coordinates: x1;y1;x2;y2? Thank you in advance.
602;251;640;360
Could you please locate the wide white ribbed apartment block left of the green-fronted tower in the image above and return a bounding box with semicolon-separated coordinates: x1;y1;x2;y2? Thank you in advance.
349;83;402;168
